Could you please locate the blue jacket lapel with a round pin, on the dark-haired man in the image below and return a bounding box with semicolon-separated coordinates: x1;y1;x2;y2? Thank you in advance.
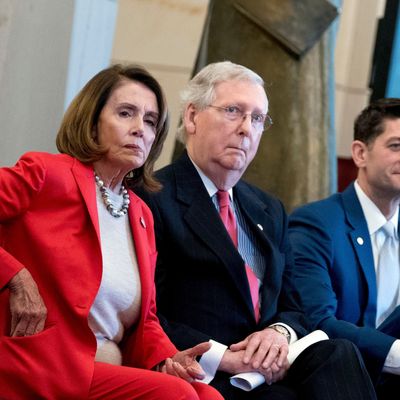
342;184;377;326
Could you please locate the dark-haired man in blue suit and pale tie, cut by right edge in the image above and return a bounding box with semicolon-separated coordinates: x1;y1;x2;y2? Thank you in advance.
289;99;400;399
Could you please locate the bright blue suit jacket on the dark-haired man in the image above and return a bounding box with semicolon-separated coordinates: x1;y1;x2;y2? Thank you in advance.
289;184;400;373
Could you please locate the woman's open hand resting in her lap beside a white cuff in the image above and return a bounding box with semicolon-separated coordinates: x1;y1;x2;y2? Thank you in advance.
161;342;211;382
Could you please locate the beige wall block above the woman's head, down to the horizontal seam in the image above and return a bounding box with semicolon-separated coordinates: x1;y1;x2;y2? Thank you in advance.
113;0;207;68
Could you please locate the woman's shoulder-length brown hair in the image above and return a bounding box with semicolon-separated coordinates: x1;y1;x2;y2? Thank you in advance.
56;64;169;191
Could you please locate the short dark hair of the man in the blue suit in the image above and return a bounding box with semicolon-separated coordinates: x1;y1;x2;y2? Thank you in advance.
354;98;400;144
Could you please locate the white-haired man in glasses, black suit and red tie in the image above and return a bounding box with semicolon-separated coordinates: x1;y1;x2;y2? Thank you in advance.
138;62;375;400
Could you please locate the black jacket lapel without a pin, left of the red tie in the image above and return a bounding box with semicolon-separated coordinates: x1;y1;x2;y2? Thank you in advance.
174;153;254;314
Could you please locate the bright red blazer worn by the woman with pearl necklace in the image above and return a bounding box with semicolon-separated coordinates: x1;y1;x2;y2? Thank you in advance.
0;153;177;400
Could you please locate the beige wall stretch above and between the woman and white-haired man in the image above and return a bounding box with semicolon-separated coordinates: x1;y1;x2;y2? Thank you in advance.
112;0;208;168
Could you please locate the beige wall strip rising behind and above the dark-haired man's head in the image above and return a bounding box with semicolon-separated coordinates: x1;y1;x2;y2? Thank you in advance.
335;0;386;157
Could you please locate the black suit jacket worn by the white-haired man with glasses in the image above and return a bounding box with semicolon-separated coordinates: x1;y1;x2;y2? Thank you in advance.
139;153;308;349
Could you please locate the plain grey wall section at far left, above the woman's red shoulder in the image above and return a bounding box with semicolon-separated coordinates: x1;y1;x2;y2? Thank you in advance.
0;0;73;166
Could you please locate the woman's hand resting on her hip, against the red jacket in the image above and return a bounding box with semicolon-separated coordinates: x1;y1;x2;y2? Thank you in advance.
8;268;47;336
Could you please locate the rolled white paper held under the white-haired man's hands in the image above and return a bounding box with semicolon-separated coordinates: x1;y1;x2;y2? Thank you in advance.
230;330;329;392
